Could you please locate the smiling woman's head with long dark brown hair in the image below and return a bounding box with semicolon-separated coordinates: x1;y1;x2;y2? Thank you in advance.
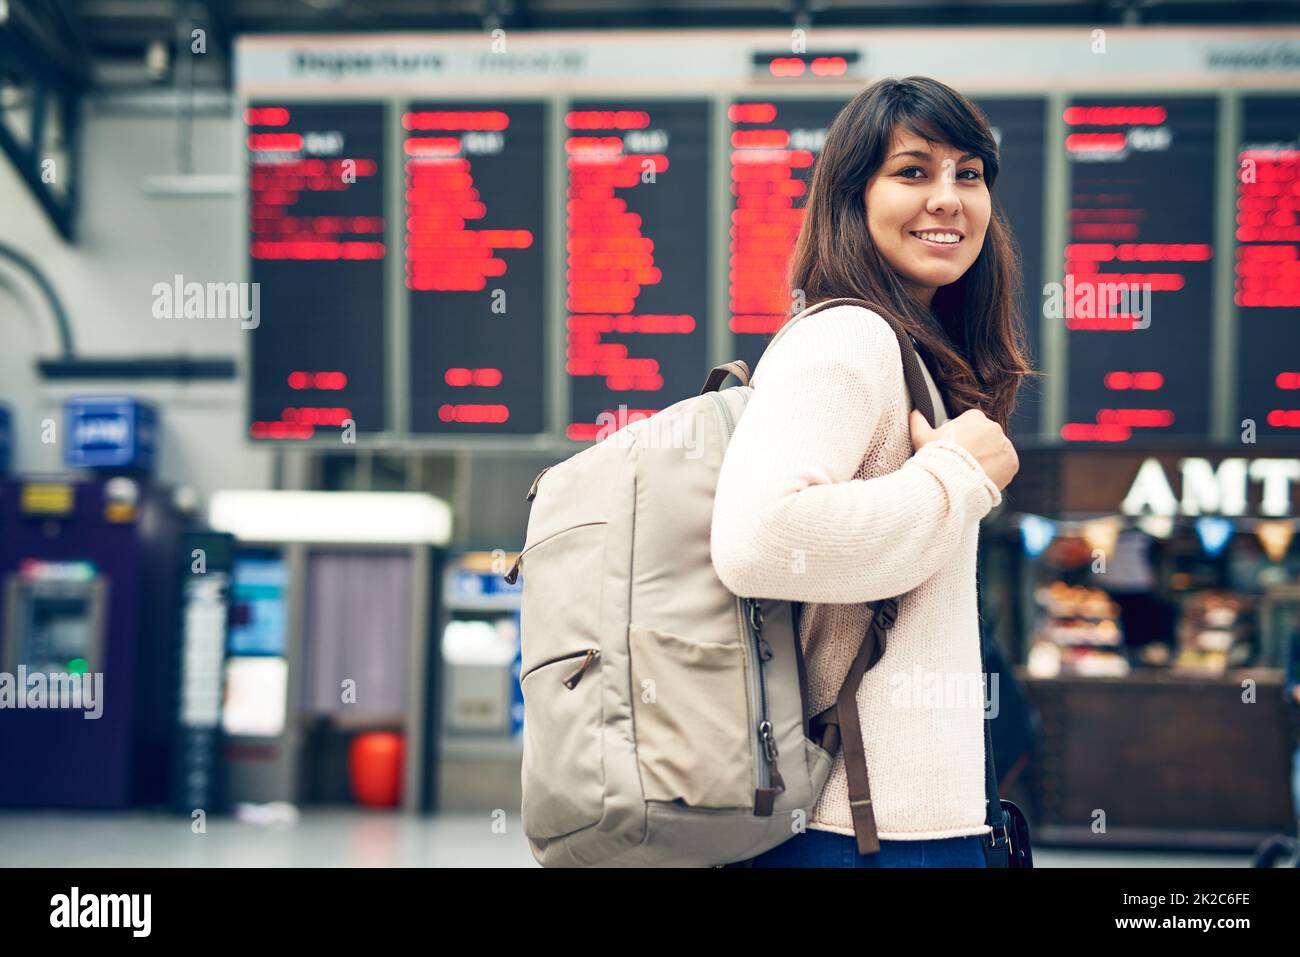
787;77;1037;429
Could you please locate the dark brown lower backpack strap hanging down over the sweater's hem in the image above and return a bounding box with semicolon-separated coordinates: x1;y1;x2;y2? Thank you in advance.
813;598;898;854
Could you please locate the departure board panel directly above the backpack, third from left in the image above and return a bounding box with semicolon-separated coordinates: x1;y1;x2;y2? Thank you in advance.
563;100;711;441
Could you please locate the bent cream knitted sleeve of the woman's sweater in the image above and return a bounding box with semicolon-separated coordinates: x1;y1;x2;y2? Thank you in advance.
711;306;1002;603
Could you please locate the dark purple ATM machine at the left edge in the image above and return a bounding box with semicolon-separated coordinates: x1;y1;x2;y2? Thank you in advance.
0;475;183;807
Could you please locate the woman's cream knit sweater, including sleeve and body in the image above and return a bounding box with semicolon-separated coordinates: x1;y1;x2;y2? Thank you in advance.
711;306;1002;840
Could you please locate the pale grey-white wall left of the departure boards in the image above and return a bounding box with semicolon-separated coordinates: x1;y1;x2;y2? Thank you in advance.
0;101;272;505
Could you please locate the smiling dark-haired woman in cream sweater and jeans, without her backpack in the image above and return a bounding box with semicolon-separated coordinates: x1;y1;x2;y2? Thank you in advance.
711;77;1036;867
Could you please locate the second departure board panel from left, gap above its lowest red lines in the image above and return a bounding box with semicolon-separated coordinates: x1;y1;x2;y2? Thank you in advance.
402;101;547;436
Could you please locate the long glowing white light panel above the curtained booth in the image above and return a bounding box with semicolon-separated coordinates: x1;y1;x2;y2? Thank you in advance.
208;489;451;545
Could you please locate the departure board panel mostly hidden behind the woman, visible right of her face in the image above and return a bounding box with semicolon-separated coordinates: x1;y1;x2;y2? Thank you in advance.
979;98;1047;441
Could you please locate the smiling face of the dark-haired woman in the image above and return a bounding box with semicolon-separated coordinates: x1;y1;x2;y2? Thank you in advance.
865;130;992;304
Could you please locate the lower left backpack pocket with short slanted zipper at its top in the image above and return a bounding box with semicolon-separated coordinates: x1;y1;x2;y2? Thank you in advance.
520;648;605;839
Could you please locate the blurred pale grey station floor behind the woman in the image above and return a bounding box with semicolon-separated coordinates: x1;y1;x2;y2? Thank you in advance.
0;809;1251;867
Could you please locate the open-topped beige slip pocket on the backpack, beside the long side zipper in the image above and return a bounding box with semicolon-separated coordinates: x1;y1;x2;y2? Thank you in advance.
628;624;755;807
